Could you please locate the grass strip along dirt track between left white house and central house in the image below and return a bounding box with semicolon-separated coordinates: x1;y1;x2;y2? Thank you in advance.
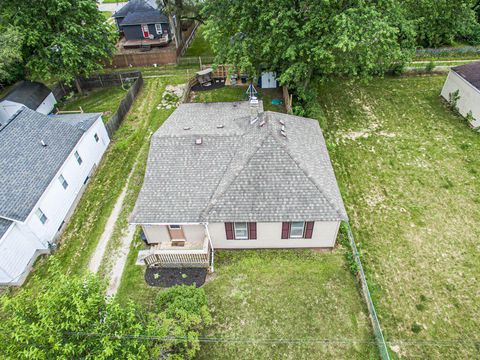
20;76;187;287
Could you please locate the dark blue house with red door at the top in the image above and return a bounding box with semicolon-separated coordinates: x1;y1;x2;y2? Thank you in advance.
112;0;171;42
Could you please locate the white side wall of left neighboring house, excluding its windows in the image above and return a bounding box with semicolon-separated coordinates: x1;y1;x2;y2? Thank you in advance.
25;117;110;243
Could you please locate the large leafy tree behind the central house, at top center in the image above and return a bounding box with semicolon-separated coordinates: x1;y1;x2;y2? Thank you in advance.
204;0;414;96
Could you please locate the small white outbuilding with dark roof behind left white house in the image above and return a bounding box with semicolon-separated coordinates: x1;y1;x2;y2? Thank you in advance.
0;80;57;126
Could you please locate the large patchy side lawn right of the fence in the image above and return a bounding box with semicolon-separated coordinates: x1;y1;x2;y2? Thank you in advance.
318;76;480;359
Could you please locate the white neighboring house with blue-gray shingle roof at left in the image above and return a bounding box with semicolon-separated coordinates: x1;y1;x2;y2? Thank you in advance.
0;107;110;285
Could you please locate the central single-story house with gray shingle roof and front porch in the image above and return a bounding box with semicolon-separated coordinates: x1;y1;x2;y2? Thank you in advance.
130;100;347;266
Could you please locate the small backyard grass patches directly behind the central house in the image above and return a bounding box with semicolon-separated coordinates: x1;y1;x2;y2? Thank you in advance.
191;86;286;113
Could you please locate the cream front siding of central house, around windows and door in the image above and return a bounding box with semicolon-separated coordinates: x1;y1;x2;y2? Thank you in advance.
143;221;340;249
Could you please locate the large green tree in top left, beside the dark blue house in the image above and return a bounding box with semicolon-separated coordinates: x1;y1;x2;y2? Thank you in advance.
0;0;116;91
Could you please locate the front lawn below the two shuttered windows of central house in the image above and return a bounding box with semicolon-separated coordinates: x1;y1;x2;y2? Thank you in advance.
198;247;378;359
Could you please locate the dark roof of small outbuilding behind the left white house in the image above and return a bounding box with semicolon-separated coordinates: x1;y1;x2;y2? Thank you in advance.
0;80;52;110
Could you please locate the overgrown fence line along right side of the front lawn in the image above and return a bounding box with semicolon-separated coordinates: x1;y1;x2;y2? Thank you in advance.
342;223;390;360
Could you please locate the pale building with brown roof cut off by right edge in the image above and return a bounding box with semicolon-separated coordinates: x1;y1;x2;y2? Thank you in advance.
442;61;480;128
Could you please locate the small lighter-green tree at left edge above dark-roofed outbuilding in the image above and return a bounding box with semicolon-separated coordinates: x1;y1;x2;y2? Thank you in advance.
0;26;23;83
